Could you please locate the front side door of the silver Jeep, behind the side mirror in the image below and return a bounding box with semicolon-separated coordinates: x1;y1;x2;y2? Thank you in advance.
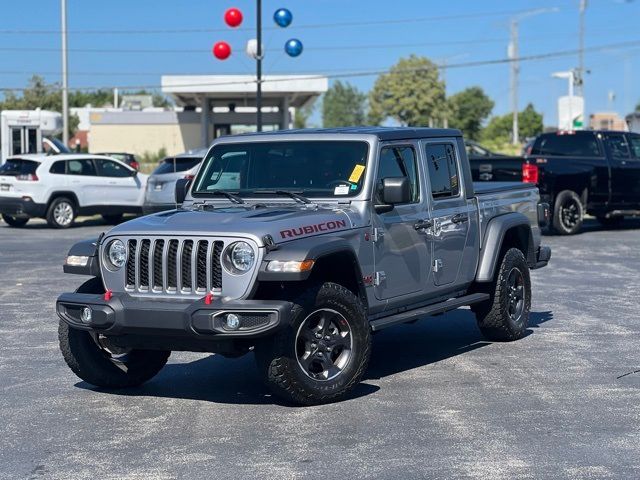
373;144;430;300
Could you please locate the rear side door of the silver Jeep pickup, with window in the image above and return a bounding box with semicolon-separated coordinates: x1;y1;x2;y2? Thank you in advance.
423;140;474;286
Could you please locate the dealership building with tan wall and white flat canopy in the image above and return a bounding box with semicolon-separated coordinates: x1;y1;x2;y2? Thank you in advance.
87;75;328;155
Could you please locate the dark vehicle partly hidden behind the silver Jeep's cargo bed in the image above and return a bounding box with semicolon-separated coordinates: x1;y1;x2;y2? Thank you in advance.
465;140;524;182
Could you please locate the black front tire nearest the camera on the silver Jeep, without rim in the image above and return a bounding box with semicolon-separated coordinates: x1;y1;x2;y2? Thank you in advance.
255;282;371;405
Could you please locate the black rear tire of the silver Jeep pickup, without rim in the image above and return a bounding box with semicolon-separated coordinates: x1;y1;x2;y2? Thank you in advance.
471;248;531;342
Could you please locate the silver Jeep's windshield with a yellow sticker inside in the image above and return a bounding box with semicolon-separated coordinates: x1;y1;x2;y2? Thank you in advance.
193;140;368;197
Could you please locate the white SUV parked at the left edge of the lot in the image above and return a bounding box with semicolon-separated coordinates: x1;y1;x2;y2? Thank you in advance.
0;154;147;228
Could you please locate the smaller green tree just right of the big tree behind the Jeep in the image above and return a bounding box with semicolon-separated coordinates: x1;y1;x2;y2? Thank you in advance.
448;87;494;140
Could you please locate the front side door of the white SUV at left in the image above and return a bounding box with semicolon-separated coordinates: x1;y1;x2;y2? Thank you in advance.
94;158;144;206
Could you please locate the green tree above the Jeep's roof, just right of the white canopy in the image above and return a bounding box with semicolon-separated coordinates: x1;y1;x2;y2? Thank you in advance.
322;80;367;127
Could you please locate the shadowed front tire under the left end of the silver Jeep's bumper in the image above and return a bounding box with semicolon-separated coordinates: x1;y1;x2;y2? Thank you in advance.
58;320;171;388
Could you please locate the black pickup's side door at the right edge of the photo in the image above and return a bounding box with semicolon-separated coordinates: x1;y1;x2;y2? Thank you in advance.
605;133;640;208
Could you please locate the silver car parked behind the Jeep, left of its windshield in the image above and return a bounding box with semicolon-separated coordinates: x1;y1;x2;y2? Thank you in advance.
143;149;207;214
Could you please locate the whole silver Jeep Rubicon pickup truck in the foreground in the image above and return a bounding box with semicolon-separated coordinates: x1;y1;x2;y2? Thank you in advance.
56;127;551;404
